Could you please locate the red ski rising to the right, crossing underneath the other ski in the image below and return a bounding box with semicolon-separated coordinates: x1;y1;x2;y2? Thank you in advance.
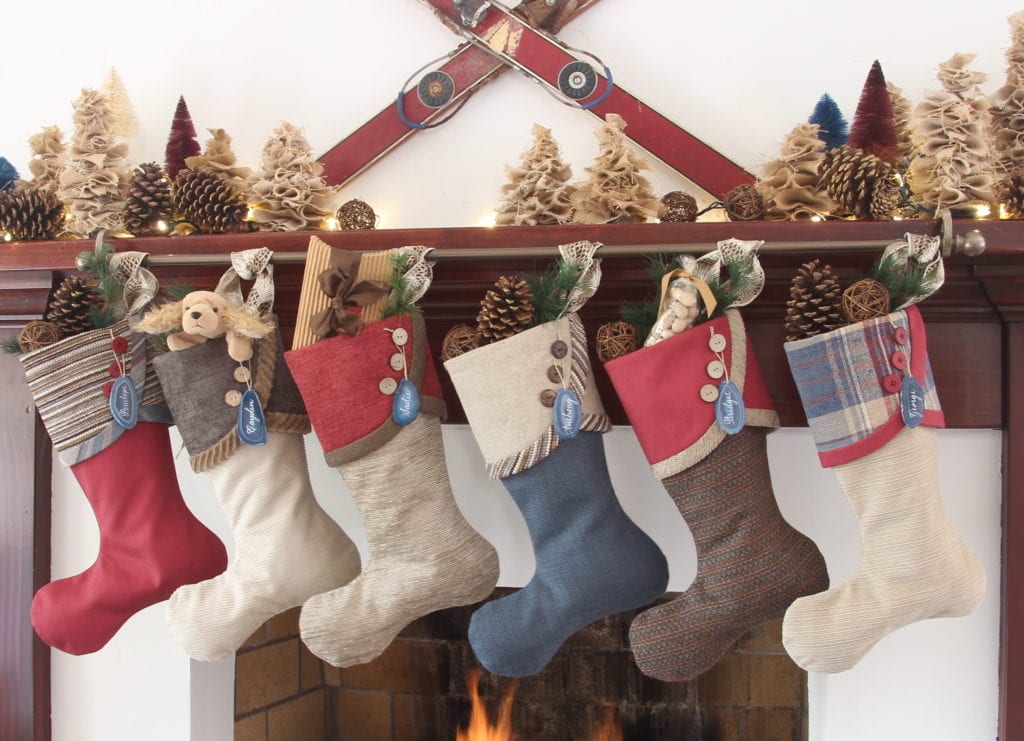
319;0;599;185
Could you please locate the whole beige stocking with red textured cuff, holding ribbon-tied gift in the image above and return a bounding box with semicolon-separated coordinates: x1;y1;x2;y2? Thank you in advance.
286;314;498;666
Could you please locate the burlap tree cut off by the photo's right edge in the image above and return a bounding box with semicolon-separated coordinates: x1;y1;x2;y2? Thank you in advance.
991;11;1024;175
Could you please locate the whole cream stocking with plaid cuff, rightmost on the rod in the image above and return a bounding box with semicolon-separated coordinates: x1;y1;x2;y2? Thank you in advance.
782;306;985;672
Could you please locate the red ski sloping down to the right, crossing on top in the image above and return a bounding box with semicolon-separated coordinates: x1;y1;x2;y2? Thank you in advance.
420;0;754;198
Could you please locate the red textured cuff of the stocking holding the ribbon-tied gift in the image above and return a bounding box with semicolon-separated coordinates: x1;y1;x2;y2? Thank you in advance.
285;314;446;467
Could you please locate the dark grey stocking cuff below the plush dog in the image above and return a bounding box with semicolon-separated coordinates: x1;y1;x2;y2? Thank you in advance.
154;315;309;473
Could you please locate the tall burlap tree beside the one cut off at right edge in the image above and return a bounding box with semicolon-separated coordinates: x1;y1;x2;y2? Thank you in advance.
909;54;994;210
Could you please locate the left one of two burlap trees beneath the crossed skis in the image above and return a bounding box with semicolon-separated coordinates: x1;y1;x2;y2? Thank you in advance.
495;124;573;226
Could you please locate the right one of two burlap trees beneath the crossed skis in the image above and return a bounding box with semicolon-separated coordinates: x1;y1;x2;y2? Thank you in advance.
572;114;658;224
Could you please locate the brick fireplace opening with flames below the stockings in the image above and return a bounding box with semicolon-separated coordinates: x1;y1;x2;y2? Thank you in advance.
236;589;807;741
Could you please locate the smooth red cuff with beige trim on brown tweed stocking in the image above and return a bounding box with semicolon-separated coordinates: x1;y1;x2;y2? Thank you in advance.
604;310;778;479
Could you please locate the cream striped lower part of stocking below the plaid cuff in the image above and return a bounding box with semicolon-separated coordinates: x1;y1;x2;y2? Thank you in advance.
782;427;985;672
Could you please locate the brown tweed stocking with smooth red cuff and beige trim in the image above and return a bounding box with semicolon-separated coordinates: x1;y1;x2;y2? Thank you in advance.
605;310;828;682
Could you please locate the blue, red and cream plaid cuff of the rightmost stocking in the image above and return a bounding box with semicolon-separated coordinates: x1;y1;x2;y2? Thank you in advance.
785;306;945;467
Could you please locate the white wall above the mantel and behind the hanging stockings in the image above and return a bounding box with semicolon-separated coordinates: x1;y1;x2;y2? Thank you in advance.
12;0;1019;741
